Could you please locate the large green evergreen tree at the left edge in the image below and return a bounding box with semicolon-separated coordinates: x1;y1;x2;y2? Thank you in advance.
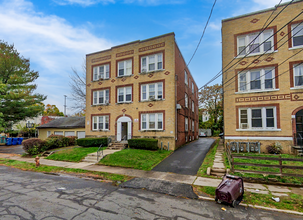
0;41;46;128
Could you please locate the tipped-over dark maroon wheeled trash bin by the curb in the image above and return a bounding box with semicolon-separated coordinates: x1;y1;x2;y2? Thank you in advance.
215;175;244;207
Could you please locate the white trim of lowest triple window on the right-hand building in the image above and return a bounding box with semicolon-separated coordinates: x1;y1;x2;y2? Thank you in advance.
236;106;281;131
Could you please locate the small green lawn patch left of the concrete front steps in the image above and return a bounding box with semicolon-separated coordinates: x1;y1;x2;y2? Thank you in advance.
46;147;98;162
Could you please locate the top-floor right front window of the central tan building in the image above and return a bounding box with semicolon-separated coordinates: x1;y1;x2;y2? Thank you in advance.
141;53;163;73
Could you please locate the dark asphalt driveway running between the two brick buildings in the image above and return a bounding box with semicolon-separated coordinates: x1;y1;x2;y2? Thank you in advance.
153;138;215;175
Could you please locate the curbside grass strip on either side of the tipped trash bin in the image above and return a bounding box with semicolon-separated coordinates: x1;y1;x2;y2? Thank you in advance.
195;186;303;212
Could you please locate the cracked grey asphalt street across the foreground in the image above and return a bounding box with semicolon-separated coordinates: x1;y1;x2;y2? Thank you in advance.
0;166;302;220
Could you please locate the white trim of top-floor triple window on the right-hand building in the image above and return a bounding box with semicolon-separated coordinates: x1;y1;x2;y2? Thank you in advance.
237;29;275;57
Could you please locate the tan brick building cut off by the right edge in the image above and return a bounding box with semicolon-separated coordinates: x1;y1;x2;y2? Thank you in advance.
222;1;303;153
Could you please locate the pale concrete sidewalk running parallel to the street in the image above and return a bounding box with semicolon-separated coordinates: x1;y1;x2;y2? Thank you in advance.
0;154;303;197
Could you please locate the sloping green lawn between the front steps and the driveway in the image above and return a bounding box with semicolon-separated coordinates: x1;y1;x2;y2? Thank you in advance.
99;149;172;170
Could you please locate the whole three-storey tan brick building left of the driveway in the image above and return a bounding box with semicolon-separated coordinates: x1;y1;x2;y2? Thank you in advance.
85;33;199;150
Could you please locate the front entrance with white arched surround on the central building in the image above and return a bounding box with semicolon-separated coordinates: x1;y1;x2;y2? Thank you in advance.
117;116;132;141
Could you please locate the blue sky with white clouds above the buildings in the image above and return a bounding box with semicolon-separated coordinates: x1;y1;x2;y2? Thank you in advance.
0;0;287;114
